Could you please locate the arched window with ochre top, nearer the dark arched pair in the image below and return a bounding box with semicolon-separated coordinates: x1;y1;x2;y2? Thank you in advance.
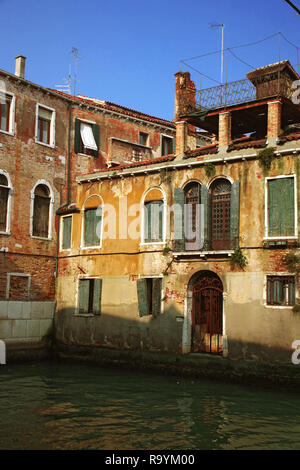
143;188;165;243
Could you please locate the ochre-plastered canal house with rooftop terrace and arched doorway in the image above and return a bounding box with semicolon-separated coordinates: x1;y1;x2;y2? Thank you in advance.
55;61;300;363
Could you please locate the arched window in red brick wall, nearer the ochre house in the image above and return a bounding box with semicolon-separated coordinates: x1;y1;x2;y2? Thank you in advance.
32;184;51;238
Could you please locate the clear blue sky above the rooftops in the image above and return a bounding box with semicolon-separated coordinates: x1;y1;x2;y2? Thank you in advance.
0;0;300;120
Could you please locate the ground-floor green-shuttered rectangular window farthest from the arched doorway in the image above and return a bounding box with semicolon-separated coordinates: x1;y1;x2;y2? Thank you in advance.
78;278;102;315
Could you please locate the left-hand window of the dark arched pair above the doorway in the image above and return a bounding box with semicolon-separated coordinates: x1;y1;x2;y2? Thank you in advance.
184;182;201;250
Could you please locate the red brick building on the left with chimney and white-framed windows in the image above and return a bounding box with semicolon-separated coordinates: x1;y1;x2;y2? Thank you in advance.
0;56;189;350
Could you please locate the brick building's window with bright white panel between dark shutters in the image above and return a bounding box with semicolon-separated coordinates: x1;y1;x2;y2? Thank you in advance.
74;119;100;157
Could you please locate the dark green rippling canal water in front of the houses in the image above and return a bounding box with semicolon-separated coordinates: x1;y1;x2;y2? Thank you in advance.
0;363;300;450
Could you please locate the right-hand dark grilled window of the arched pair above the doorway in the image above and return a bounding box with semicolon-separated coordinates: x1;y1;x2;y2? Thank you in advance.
211;178;231;250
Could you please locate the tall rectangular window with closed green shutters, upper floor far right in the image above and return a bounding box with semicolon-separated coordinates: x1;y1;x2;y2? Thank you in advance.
266;176;295;238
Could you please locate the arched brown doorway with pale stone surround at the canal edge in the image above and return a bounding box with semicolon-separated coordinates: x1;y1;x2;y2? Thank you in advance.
191;271;223;354
